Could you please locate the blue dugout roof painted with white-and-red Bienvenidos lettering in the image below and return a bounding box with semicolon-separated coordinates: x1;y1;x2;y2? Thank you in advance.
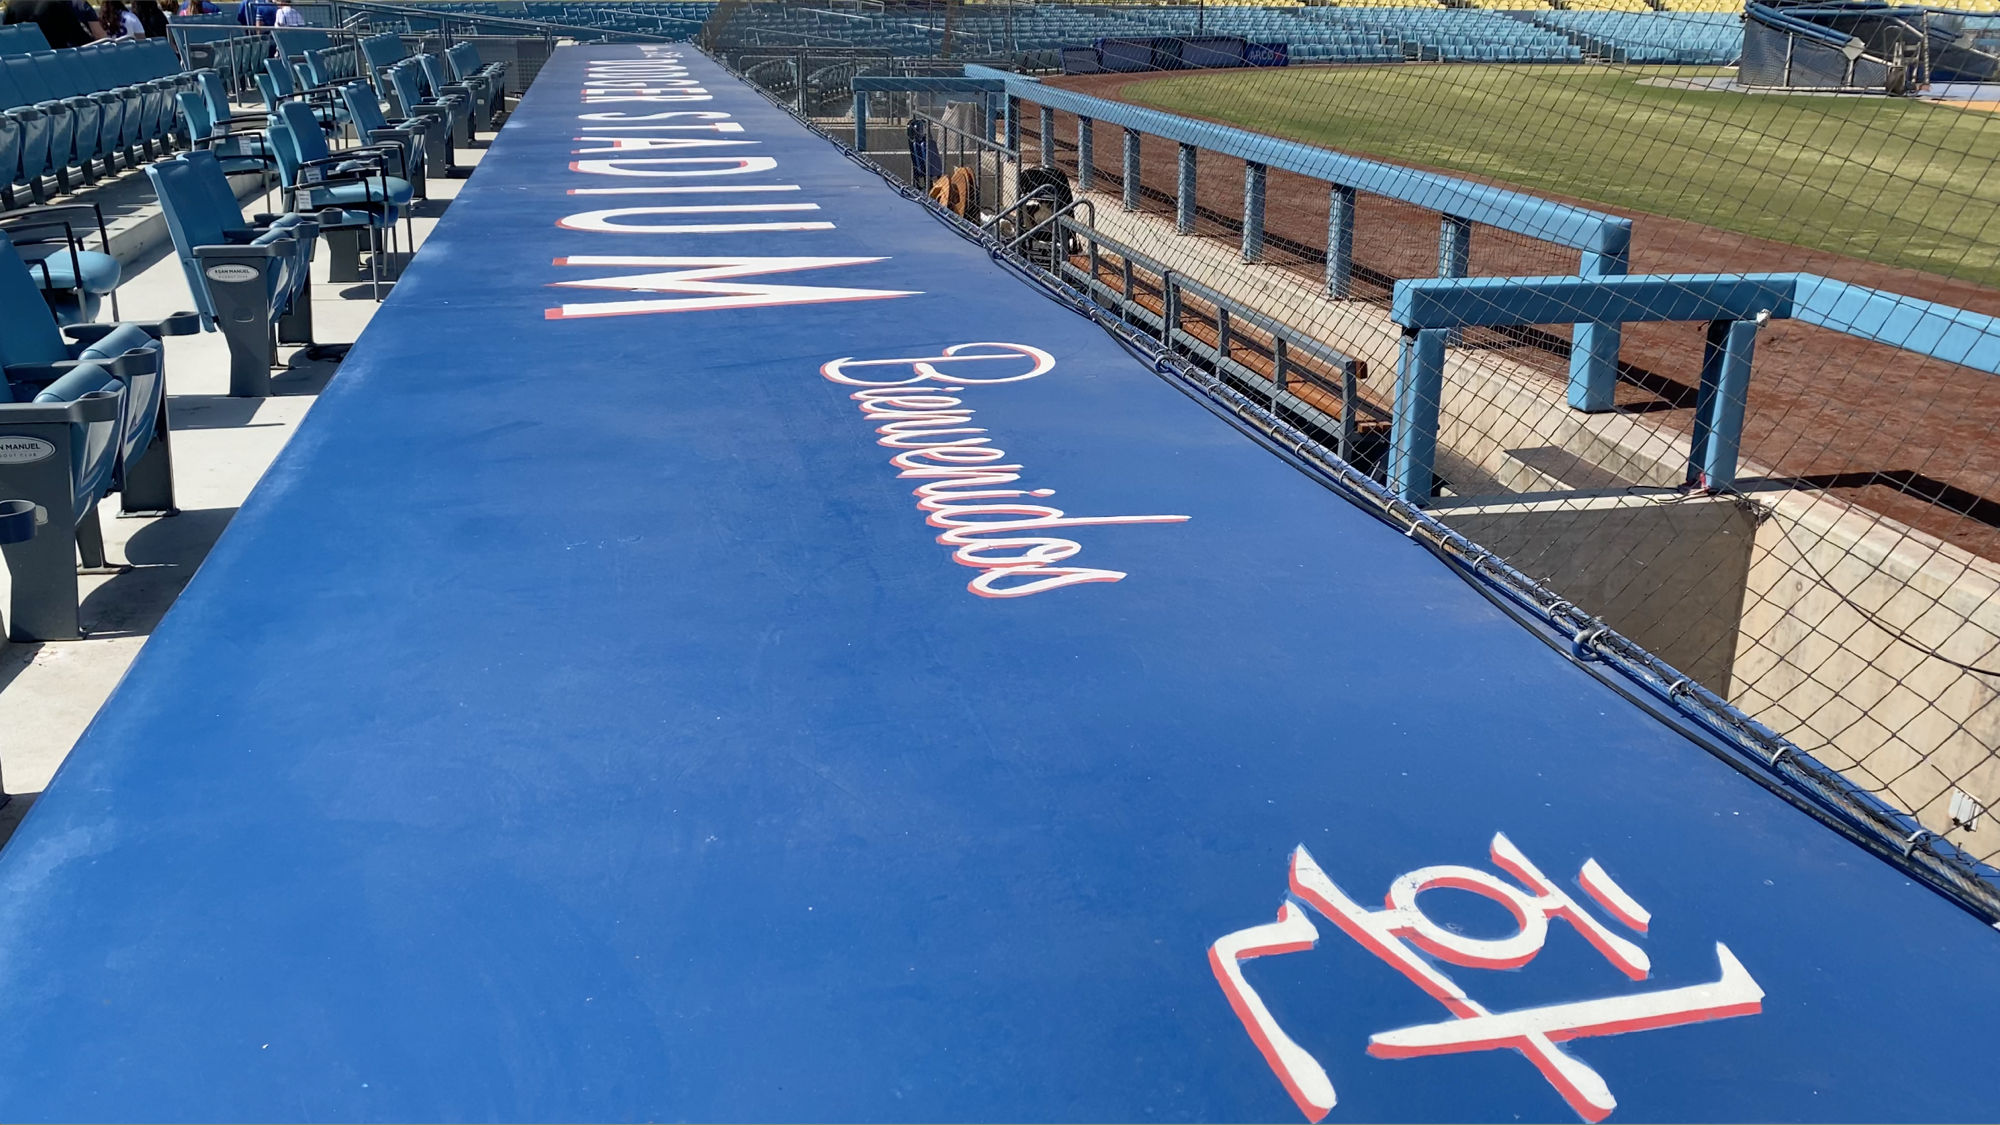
0;46;2000;1121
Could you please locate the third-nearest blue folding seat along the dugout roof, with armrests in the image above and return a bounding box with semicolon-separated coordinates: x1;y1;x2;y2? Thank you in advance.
270;102;414;300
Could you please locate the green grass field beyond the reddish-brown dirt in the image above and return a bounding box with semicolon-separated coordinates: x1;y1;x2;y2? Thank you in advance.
1124;66;2000;286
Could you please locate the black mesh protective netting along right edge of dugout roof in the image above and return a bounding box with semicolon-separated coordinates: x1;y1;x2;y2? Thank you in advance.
704;0;2000;892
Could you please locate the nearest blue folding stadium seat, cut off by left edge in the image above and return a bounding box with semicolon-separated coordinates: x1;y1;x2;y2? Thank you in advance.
0;228;196;641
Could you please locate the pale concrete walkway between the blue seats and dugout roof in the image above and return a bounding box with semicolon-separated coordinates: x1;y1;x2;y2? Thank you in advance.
0;134;490;839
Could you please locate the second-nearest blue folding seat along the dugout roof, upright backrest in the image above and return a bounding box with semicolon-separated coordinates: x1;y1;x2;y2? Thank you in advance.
146;152;326;398
